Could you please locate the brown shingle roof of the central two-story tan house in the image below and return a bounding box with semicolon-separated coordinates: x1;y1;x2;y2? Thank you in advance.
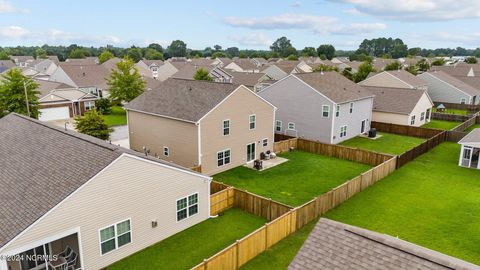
125;78;239;122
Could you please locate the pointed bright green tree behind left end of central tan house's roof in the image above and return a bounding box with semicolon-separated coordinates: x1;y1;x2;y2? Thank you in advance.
107;56;145;102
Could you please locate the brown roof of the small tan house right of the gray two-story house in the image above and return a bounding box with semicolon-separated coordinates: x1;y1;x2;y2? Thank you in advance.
363;86;433;115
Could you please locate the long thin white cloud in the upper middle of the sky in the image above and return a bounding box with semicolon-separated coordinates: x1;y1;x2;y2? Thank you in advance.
224;14;387;35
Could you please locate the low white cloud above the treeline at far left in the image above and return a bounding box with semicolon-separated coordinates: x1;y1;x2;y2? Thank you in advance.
0;26;121;45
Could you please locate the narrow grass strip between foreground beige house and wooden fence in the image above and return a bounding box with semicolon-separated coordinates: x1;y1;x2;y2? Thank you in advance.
108;209;266;270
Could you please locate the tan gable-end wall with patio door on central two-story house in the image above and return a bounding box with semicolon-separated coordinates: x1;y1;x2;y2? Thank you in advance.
200;86;274;175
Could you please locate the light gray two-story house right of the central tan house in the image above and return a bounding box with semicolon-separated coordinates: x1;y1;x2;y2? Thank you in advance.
258;72;373;144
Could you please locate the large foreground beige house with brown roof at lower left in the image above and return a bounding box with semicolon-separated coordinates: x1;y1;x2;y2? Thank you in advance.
0;113;211;270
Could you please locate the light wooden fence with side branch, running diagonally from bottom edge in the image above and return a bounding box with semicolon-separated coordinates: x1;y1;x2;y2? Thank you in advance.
200;157;397;270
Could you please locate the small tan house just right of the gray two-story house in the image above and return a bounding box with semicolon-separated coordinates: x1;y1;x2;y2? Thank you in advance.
364;86;434;127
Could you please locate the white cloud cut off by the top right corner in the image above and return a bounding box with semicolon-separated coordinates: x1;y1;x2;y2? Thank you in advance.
330;0;480;21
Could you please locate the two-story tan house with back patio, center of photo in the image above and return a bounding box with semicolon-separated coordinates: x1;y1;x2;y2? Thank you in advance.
125;79;275;175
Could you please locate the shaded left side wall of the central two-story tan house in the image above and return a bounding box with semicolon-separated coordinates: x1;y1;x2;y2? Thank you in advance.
128;110;199;168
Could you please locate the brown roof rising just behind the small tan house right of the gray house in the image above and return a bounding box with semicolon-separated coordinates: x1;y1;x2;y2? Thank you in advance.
358;70;428;90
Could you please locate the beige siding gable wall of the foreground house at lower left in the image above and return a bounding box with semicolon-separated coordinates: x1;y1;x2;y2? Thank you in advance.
2;155;209;269
